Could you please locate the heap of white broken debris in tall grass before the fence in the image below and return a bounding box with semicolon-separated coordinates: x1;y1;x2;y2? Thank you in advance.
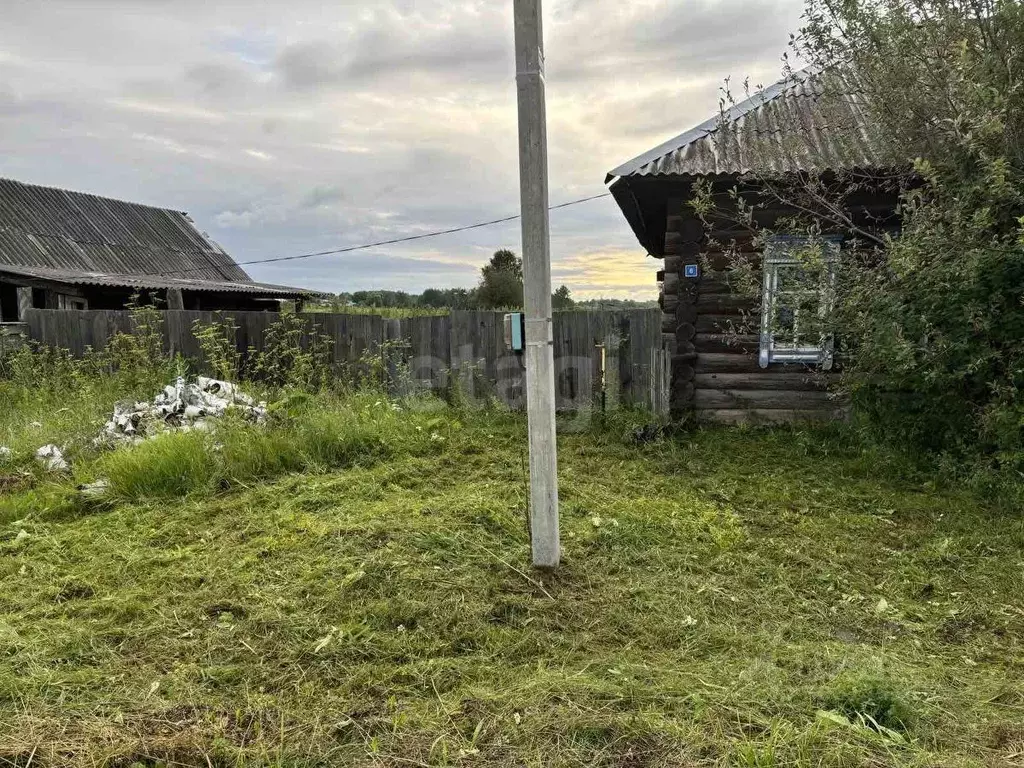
95;376;266;444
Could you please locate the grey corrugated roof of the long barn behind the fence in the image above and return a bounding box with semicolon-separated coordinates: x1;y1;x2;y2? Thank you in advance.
0;178;314;296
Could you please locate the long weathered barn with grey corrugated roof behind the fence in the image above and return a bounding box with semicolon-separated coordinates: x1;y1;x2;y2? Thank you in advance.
0;179;313;322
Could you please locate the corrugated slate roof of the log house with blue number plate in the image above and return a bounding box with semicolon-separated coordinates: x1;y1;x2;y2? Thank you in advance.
607;68;888;181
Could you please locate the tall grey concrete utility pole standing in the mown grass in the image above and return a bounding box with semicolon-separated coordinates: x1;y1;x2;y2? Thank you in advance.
513;0;559;568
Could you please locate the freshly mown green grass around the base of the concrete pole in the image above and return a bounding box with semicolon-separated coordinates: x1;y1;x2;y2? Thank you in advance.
0;405;1024;768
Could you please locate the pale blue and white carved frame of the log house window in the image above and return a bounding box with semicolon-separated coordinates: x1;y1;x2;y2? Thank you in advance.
758;237;841;371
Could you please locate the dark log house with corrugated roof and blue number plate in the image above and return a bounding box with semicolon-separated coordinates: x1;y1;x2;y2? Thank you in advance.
606;69;905;423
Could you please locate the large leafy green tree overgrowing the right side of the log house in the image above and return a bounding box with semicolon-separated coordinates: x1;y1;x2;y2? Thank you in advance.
691;0;1024;480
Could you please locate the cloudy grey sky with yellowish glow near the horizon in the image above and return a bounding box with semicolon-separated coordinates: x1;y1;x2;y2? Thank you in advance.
0;0;802;299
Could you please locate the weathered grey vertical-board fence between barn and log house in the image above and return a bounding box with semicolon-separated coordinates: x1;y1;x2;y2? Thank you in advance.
25;309;670;415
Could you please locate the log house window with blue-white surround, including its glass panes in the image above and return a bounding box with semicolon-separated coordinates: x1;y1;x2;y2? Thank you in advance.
758;237;840;371
